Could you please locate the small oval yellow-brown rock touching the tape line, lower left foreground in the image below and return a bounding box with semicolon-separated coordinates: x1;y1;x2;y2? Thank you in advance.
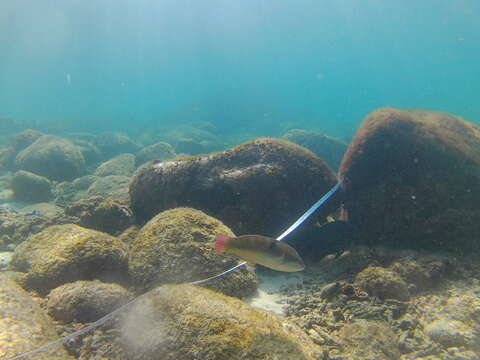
47;280;132;322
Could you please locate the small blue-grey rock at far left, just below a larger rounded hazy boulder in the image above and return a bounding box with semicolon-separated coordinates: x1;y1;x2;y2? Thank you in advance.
10;170;53;203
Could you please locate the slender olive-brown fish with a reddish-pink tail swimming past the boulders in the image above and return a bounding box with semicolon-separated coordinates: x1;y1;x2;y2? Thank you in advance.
215;235;305;272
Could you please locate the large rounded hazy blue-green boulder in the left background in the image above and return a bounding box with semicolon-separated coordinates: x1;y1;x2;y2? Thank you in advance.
15;135;85;181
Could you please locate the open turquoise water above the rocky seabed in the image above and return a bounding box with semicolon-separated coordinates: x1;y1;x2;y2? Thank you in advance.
0;0;480;137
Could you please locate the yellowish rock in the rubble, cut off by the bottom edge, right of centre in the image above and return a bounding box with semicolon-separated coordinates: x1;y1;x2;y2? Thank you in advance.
332;320;400;360
